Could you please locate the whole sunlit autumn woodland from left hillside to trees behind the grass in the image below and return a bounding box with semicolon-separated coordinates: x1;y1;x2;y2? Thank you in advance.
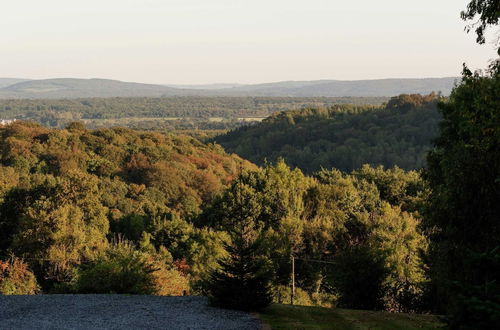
0;122;426;311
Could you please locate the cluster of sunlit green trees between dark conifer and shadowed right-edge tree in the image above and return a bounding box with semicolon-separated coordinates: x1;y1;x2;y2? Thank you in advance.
201;161;427;311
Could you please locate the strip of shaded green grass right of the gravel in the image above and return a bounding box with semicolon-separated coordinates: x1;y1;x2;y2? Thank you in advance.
259;304;443;330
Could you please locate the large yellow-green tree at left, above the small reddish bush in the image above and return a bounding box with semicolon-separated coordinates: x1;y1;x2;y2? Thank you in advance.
2;172;108;281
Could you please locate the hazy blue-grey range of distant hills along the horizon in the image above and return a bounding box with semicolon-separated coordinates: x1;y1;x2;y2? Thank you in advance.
0;77;458;99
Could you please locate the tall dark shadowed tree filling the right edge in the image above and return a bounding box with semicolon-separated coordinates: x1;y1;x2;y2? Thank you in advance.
424;63;500;329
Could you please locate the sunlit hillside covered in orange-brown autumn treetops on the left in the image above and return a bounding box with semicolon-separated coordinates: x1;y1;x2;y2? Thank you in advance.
0;121;254;217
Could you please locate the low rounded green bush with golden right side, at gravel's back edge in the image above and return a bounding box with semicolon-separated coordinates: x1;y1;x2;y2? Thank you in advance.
74;242;188;295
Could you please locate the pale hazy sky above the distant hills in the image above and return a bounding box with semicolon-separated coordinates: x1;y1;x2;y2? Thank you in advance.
0;0;495;84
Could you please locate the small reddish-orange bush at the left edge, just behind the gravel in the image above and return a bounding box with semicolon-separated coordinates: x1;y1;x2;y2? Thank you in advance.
0;258;39;295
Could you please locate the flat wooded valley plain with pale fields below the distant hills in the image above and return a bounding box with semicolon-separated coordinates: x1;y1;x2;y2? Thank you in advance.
0;96;387;129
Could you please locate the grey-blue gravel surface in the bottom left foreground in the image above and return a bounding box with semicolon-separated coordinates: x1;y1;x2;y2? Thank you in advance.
0;295;261;330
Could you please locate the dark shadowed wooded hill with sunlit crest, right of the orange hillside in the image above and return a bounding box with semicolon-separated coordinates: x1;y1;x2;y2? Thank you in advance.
212;94;441;173
